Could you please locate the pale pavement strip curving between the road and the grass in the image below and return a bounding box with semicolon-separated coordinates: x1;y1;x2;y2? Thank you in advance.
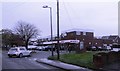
36;58;92;71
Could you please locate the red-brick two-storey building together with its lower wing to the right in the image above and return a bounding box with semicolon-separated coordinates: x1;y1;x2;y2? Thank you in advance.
61;31;120;50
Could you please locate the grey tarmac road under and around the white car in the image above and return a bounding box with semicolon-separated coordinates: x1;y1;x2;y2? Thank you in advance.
2;51;63;71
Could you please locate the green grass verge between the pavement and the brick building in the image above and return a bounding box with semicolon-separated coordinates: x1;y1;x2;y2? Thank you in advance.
48;52;95;69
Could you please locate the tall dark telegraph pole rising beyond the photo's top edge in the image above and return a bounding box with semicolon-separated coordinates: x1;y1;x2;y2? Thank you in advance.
57;0;60;59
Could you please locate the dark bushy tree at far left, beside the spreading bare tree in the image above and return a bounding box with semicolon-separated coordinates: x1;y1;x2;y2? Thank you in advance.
1;29;23;49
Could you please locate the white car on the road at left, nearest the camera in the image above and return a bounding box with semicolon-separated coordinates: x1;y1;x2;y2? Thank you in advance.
8;47;31;58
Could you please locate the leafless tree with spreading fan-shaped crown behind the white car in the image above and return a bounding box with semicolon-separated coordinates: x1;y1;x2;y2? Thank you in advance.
15;21;38;49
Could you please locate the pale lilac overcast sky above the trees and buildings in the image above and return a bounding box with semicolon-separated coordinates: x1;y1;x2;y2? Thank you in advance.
0;0;118;37
